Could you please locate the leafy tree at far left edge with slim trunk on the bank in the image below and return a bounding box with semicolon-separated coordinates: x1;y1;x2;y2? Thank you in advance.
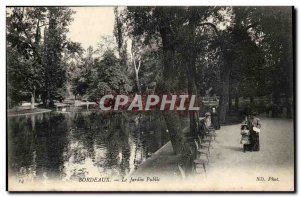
6;7;47;109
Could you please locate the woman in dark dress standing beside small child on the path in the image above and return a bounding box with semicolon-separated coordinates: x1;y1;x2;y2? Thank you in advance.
248;112;261;151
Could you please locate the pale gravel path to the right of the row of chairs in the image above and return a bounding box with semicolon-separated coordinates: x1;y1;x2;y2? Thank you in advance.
192;117;294;191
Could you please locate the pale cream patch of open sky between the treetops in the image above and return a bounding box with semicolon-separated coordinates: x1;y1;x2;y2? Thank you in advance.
68;7;115;49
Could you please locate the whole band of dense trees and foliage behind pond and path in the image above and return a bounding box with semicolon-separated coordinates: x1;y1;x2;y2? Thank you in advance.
6;6;294;153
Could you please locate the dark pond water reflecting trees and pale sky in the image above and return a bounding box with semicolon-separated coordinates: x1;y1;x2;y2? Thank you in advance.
8;112;168;181
